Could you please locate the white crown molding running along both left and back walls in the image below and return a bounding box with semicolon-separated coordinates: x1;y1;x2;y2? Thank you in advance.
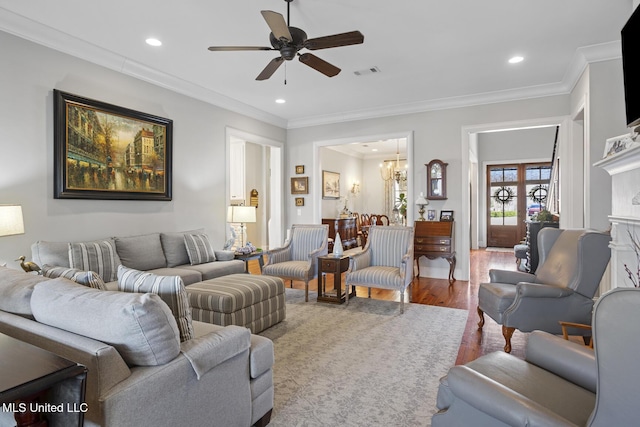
0;8;621;129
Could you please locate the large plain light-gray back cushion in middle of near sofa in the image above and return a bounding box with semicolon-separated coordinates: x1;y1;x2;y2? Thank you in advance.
31;278;180;366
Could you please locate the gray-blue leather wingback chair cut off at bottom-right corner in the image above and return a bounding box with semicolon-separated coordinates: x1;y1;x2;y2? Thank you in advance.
431;288;640;427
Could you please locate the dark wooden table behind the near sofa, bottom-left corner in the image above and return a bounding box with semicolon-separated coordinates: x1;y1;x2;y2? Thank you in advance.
0;334;87;427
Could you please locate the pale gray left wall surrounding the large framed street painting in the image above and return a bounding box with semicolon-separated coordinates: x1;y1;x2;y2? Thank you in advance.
0;32;286;268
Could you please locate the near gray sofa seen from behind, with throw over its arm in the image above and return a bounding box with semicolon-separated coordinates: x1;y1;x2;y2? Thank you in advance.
0;267;274;427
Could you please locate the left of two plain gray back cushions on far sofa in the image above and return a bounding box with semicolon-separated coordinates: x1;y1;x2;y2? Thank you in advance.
115;233;167;271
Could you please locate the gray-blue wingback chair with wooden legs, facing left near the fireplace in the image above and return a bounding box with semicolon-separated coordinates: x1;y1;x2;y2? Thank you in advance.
478;228;611;353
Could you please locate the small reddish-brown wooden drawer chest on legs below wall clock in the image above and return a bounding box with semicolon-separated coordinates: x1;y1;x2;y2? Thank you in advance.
413;221;456;283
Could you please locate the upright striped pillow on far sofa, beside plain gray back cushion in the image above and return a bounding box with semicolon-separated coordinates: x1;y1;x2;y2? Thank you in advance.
69;240;120;282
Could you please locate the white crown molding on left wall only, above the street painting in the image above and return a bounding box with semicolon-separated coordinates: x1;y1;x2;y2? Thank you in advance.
0;8;287;128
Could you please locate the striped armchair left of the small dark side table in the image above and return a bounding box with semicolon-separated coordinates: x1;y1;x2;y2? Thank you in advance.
262;224;329;301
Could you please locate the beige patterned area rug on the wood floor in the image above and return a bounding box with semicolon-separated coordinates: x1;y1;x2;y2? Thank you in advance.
261;289;468;427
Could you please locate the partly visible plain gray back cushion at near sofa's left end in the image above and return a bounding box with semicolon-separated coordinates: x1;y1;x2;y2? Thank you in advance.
0;266;50;318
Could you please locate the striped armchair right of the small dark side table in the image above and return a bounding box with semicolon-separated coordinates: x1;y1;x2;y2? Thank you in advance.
346;226;413;313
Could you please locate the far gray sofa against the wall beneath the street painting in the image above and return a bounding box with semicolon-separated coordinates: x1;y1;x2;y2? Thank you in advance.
31;229;245;290
